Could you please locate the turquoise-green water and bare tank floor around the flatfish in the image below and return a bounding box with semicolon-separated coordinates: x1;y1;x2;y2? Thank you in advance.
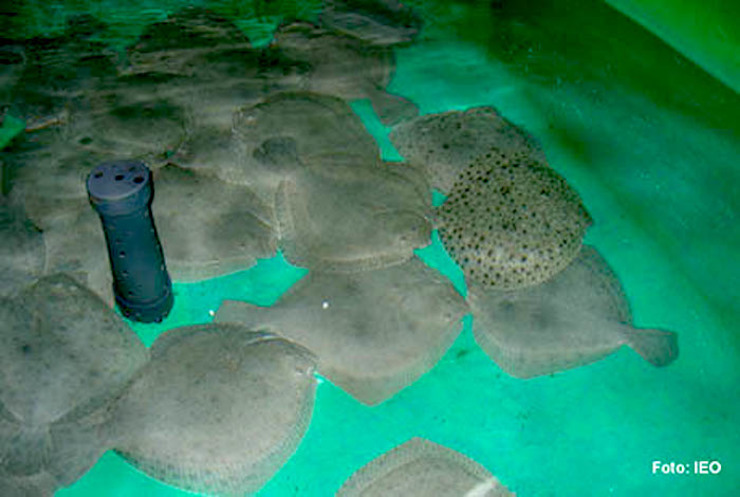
4;0;740;497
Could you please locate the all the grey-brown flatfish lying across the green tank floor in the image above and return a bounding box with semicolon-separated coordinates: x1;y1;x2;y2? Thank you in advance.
0;1;677;496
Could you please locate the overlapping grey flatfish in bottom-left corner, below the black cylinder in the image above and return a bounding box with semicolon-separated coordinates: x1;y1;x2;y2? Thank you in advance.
0;273;316;497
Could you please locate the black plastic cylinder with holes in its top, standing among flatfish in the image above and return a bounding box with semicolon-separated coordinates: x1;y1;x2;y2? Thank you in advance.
87;161;174;323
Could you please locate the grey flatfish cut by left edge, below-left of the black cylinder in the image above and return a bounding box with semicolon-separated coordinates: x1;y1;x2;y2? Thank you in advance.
0;274;148;425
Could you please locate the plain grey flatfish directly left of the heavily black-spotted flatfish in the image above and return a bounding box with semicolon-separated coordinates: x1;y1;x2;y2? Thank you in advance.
276;156;431;272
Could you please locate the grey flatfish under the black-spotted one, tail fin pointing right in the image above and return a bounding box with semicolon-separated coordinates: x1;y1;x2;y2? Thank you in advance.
468;246;678;378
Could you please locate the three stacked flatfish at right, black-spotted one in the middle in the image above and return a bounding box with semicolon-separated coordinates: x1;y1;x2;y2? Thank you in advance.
391;107;678;378
